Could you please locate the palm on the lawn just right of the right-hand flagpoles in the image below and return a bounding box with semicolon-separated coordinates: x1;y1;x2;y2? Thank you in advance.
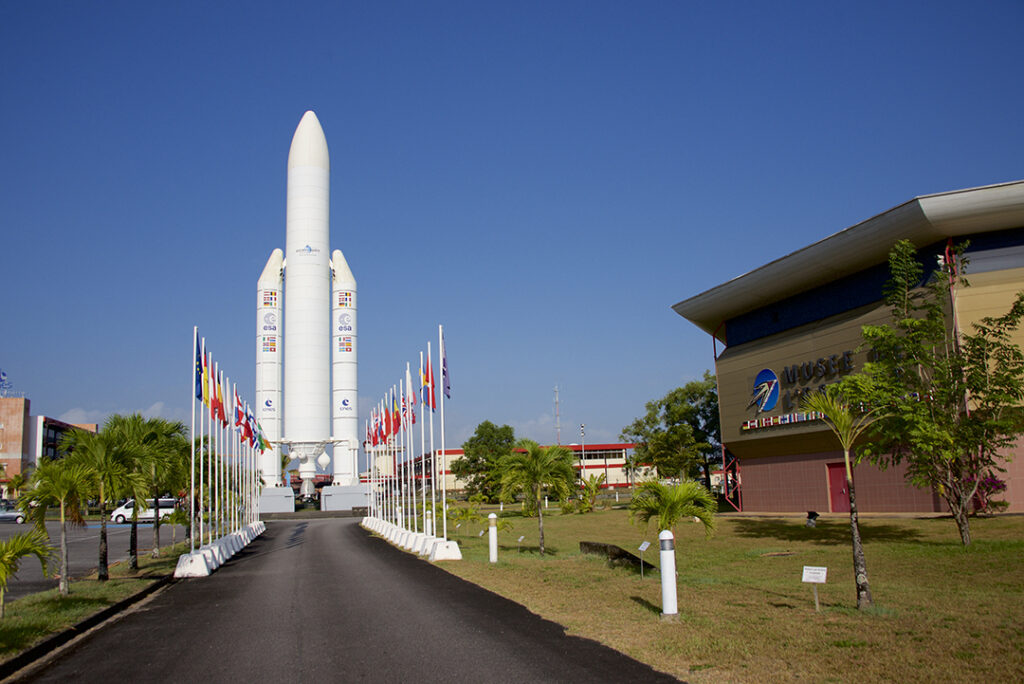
499;439;575;556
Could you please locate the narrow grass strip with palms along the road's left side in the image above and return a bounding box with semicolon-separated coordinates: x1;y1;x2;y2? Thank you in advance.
0;544;187;661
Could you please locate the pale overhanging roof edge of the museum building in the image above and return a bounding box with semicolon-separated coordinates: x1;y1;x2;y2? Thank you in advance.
672;180;1024;341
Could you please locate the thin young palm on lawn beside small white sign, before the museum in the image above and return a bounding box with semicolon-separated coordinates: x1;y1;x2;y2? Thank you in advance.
801;386;882;610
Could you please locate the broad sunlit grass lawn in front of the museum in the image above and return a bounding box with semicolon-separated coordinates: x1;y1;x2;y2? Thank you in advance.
443;508;1024;682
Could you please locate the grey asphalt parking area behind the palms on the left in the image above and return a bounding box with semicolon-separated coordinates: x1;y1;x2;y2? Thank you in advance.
0;521;184;601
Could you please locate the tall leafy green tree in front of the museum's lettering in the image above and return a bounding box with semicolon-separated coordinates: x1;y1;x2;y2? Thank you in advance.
843;241;1024;546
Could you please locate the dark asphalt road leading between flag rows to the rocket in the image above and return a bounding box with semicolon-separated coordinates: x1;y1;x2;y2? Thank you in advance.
17;518;676;684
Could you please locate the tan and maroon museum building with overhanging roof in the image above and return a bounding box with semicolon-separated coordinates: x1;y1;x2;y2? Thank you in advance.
673;181;1024;512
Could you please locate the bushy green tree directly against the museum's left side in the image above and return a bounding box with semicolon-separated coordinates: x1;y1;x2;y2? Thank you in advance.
620;371;721;489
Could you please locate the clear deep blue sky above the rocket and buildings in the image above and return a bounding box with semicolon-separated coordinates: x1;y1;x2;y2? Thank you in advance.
0;0;1024;445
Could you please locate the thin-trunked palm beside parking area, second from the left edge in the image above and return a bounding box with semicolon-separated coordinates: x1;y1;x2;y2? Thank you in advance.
22;459;92;596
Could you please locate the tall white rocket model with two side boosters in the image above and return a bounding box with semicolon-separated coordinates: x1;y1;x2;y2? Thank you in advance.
256;112;358;496
